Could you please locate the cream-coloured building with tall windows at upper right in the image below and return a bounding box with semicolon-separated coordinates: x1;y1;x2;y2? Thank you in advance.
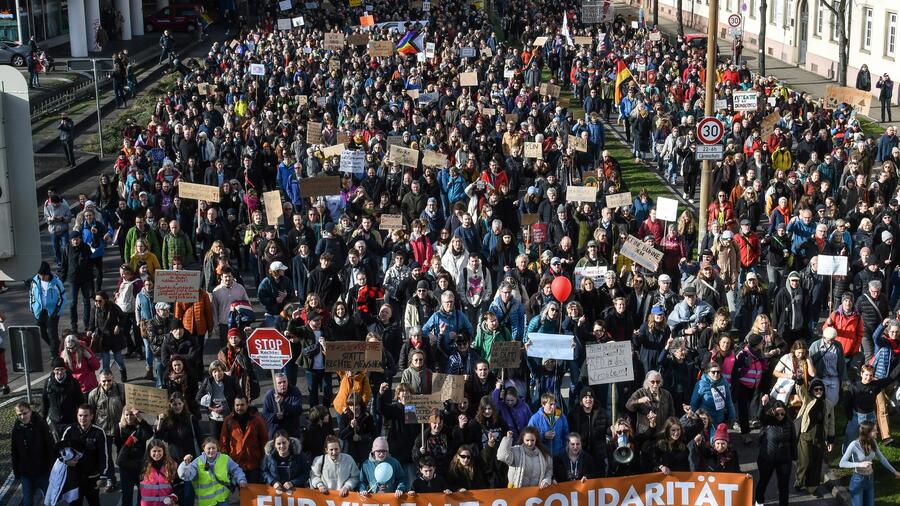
644;0;900;103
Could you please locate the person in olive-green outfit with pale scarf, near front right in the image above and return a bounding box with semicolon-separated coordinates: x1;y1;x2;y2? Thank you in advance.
794;378;834;494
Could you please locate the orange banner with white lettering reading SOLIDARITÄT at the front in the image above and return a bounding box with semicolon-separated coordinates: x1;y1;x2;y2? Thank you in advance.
241;473;753;506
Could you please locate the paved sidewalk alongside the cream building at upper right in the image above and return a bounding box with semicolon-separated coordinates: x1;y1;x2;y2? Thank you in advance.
615;2;900;127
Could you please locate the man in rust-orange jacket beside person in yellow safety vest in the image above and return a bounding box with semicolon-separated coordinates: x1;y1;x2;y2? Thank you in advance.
219;393;268;484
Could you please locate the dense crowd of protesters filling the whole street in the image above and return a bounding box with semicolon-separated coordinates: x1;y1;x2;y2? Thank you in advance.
13;1;900;506
